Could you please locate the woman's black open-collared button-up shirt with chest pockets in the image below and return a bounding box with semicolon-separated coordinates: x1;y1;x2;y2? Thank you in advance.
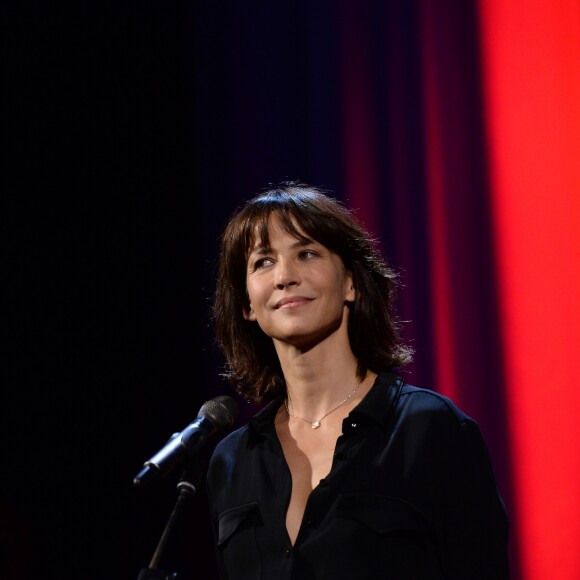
207;373;509;580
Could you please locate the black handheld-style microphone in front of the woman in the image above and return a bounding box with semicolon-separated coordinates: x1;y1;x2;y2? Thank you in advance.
133;395;239;487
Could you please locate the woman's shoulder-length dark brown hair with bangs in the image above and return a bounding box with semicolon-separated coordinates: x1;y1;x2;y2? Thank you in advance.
213;181;412;403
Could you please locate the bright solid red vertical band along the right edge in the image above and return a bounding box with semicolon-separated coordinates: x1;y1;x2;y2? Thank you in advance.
480;0;580;580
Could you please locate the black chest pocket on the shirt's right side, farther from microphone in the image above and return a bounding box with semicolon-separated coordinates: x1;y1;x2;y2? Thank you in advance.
336;494;443;580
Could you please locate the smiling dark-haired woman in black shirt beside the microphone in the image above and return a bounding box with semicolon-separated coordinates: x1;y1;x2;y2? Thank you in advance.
207;182;509;580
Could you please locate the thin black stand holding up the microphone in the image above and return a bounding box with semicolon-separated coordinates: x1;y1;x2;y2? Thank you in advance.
137;458;201;580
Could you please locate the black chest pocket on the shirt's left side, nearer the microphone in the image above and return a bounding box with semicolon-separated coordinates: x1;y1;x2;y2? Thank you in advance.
217;502;263;580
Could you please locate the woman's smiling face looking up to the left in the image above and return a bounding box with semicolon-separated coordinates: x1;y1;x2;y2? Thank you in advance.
244;214;355;347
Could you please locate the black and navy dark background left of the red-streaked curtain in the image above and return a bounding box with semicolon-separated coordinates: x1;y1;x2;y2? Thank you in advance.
0;0;341;580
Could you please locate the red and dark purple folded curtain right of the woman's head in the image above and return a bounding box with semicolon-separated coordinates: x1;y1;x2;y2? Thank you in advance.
340;0;580;580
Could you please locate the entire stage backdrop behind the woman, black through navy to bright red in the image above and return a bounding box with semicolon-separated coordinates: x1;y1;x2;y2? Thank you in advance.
5;0;580;580
